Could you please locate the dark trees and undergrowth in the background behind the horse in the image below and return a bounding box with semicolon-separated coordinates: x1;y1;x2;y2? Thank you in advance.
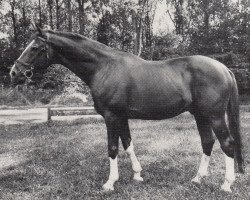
0;0;250;105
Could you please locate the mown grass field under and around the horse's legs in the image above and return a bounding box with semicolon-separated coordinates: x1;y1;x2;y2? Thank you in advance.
0;111;250;200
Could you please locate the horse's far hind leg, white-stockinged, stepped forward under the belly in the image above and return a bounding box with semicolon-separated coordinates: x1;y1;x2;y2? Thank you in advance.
192;115;215;183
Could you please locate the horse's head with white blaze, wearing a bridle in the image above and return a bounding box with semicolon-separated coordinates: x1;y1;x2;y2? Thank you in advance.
10;26;50;85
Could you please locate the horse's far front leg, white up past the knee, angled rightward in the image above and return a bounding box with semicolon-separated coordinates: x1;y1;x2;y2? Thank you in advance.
120;125;143;181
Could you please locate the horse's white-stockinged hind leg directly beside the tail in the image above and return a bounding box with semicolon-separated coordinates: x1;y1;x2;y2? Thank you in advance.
211;114;235;192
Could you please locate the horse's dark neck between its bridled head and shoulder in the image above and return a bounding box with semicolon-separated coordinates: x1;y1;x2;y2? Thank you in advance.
50;33;109;85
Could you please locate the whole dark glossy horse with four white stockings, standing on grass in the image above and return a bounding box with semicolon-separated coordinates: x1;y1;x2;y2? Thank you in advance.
10;27;244;191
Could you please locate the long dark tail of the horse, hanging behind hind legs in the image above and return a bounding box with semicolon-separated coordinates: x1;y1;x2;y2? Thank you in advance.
227;72;245;173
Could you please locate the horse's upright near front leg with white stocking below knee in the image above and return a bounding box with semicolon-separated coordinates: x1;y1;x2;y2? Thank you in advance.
103;111;122;191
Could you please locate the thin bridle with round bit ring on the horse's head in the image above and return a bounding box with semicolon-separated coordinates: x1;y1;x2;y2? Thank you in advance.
15;37;49;79
